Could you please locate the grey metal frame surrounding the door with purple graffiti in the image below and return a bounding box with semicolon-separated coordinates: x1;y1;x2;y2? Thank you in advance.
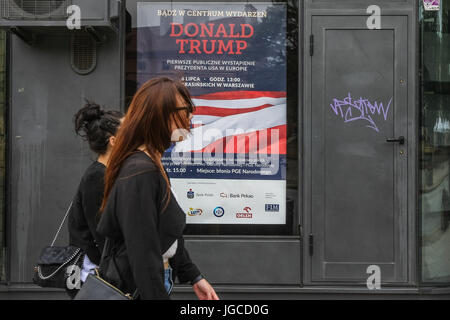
301;0;419;287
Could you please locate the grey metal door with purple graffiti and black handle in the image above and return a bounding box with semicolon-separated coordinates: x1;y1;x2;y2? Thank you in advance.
305;16;408;284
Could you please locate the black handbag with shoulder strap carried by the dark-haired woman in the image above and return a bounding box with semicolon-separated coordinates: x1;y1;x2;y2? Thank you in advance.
33;203;84;290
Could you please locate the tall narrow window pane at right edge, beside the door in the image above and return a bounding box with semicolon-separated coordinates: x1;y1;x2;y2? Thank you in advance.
419;0;450;282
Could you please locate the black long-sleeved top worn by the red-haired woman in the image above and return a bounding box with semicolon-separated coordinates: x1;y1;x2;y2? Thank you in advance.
97;151;200;299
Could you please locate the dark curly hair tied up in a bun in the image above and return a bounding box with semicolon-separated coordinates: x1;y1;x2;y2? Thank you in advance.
74;100;123;154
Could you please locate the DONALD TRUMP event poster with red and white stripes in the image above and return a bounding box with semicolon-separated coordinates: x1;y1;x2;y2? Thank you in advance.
137;2;287;224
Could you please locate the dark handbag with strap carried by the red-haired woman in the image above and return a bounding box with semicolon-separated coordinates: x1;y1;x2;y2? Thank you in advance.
74;238;138;300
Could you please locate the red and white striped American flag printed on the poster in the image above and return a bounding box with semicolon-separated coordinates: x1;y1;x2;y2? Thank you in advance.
173;91;287;154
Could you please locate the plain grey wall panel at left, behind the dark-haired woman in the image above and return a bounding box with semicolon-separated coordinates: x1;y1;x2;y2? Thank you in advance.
8;32;121;283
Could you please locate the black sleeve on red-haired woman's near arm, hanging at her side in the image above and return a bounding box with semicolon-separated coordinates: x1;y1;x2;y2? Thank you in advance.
112;171;169;300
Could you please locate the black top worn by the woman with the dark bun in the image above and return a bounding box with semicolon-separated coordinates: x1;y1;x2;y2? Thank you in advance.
69;161;106;265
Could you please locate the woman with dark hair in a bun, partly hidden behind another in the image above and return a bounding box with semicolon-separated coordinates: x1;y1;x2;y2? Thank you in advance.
67;101;123;298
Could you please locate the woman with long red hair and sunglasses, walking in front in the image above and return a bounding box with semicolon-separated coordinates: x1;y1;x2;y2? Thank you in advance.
97;77;218;300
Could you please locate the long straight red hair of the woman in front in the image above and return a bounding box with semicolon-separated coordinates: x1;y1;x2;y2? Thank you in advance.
100;77;194;212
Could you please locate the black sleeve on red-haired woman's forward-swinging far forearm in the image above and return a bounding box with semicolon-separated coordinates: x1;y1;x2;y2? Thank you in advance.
169;238;200;283
